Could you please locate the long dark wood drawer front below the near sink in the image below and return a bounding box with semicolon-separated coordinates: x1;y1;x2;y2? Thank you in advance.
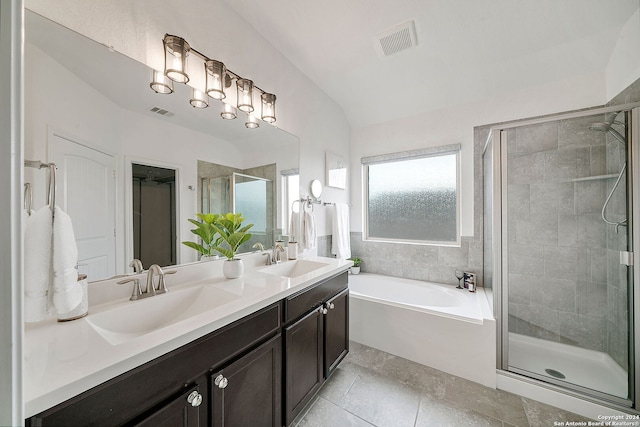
27;302;282;426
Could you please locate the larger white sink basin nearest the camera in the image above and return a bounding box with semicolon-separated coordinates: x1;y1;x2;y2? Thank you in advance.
86;286;239;345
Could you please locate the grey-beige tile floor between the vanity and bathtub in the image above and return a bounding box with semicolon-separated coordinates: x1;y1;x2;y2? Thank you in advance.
293;341;588;427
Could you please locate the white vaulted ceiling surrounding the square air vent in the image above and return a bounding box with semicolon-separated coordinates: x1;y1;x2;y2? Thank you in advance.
225;0;640;127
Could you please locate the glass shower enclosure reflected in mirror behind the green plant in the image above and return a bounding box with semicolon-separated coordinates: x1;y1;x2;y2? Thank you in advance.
202;173;275;253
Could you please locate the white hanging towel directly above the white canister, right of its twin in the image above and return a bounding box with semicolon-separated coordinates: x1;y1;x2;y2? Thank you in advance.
53;206;83;314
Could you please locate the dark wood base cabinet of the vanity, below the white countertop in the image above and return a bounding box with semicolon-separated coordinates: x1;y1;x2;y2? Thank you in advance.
25;272;349;427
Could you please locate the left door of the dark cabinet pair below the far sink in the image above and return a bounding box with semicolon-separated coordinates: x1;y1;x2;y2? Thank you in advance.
285;307;324;425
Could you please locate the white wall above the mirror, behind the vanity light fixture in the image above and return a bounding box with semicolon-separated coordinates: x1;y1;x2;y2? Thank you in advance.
25;0;349;247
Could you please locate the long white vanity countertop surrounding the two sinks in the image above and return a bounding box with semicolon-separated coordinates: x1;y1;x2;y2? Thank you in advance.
23;254;352;417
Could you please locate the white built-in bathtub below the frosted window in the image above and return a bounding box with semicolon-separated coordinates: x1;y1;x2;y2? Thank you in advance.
349;273;496;387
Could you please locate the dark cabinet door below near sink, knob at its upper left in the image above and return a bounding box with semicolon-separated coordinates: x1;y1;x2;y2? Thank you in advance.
210;335;282;427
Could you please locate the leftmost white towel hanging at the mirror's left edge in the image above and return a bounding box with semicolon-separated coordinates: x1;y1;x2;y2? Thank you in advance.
24;206;53;322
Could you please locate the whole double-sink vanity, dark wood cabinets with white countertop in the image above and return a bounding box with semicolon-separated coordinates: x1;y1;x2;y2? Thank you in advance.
25;257;350;426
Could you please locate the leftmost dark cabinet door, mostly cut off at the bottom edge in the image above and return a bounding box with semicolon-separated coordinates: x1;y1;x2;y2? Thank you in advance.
130;386;206;427
